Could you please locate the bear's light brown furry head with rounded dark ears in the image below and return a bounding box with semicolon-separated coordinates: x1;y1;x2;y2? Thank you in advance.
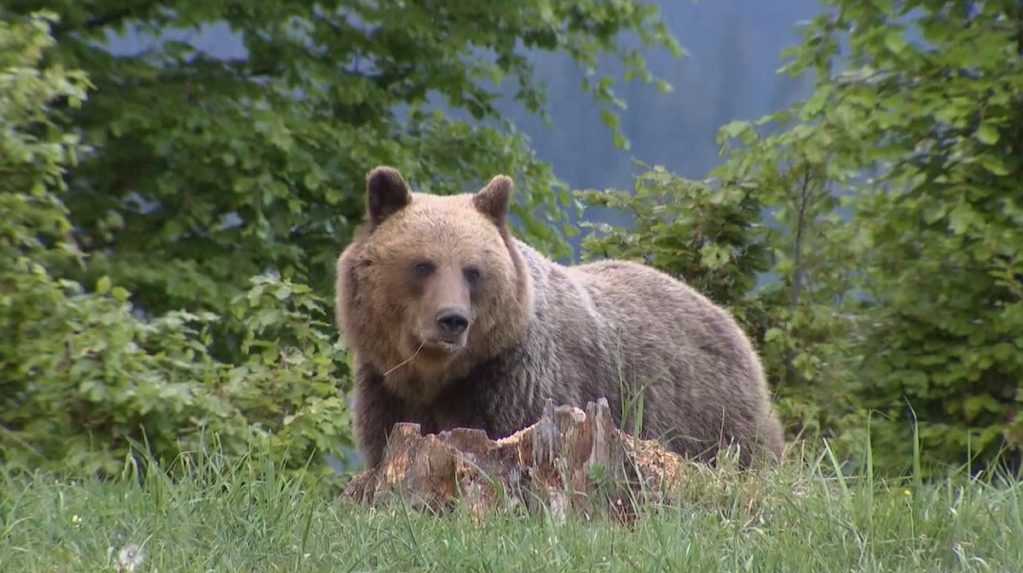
337;167;532;403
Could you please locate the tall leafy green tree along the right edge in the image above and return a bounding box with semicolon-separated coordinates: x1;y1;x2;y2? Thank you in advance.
773;1;1023;474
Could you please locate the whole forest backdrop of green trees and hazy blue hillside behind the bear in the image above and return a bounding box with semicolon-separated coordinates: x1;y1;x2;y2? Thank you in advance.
0;0;1023;475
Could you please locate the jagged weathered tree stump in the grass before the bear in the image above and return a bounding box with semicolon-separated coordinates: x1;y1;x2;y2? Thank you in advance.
345;399;696;520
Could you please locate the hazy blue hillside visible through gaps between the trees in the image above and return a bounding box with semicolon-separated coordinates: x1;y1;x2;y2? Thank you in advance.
110;0;819;188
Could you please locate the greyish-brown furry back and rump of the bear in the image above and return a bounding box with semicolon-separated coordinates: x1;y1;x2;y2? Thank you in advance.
515;241;782;466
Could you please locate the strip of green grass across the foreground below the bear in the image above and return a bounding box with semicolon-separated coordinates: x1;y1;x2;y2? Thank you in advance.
0;450;1023;573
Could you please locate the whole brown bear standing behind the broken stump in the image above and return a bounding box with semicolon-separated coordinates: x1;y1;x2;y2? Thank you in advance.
337;167;783;467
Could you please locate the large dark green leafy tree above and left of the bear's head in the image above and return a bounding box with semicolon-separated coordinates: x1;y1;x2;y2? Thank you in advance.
0;0;678;352
